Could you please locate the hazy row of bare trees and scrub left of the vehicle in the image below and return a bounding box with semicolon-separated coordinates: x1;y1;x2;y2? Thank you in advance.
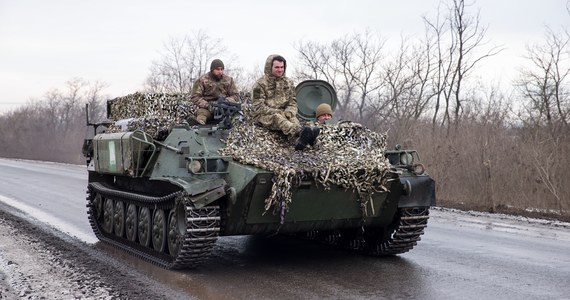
0;78;106;163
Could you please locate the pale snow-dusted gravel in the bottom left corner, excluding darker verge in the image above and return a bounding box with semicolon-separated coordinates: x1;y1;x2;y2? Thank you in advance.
0;213;123;299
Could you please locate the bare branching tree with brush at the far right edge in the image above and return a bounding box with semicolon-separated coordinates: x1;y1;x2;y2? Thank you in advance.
515;27;570;212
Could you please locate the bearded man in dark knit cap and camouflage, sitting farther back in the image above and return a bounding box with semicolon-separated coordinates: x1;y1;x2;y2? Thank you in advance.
190;59;239;124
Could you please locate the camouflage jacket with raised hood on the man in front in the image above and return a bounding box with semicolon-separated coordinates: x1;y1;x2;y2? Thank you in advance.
252;55;297;123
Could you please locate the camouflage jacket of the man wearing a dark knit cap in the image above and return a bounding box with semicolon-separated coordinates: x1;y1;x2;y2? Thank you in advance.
190;72;239;108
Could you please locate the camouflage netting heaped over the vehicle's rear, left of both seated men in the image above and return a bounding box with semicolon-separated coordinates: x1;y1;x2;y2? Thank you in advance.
109;93;196;139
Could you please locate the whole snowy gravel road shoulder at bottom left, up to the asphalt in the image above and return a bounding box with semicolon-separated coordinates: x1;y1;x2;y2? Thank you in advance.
0;210;188;300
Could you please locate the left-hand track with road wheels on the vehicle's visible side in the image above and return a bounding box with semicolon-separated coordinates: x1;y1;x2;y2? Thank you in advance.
87;182;220;269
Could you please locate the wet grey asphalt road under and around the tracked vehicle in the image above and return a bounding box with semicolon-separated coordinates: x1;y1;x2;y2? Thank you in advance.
0;159;570;299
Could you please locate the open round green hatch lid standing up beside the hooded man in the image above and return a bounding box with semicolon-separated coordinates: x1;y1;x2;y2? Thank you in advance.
295;80;338;121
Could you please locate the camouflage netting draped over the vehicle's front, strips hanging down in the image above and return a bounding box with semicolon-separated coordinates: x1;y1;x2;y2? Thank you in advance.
220;106;389;222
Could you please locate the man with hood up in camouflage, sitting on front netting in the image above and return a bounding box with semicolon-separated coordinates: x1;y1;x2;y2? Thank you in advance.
252;55;320;150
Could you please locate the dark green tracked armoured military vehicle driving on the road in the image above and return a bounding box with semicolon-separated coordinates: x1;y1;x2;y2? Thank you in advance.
83;80;435;269
